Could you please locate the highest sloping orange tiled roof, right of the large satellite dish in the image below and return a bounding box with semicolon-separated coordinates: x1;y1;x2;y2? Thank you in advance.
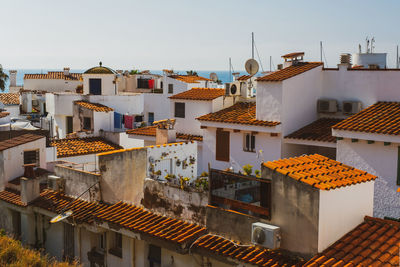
256;62;322;82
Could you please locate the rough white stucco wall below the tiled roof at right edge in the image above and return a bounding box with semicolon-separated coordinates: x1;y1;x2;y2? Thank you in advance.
336;139;400;218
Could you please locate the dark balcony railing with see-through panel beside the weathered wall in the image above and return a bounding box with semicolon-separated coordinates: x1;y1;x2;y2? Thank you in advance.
209;169;271;218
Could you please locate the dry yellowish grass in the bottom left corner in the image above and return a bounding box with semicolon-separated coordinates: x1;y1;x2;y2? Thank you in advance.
0;235;79;267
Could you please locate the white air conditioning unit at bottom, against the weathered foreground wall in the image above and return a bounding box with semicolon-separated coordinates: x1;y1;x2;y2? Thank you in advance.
251;222;281;249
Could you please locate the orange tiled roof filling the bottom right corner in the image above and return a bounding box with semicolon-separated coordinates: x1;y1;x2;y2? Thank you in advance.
304;216;400;267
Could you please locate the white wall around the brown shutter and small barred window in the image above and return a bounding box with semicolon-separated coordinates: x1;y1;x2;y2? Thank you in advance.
202;128;281;173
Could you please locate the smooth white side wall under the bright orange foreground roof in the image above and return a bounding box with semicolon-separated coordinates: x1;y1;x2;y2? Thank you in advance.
318;181;374;252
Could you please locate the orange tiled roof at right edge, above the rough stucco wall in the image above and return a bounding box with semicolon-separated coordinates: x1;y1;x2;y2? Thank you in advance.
332;102;400;135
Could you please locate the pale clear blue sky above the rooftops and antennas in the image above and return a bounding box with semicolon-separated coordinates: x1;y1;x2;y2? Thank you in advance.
0;0;400;70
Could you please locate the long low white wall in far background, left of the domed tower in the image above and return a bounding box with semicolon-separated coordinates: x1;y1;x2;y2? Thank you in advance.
24;79;82;92
